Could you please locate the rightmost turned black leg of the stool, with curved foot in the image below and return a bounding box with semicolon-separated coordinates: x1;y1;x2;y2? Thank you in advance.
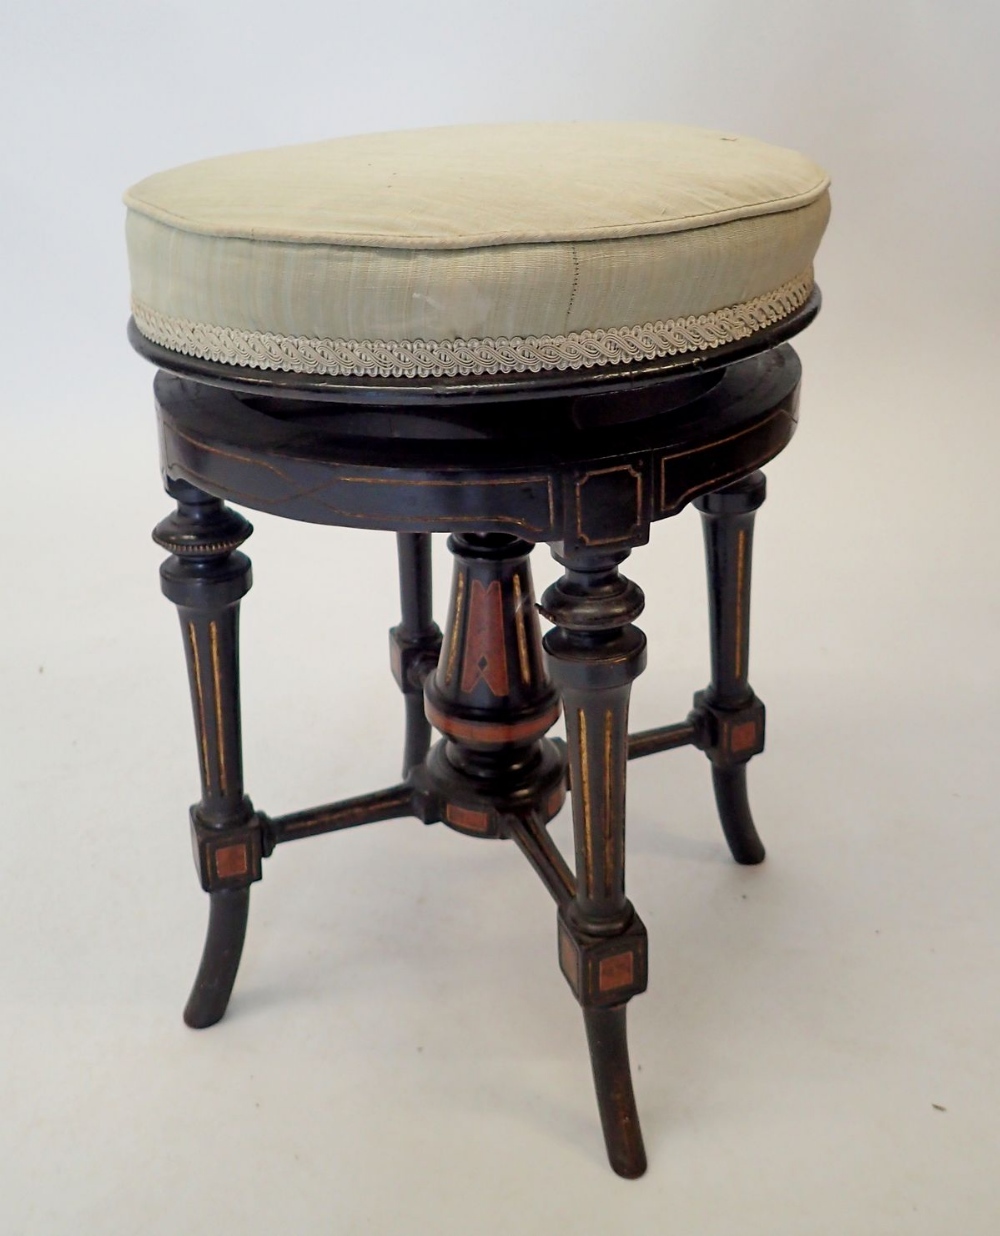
695;472;766;864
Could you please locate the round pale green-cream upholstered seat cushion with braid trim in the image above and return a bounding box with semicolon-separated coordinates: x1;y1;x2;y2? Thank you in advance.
125;124;829;378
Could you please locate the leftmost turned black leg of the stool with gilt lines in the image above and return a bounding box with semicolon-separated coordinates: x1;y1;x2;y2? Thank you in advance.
153;481;261;1028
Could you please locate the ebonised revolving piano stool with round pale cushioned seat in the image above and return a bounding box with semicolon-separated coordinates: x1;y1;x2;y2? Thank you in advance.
126;124;829;1177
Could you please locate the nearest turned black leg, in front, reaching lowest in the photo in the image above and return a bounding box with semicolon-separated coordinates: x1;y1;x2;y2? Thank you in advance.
541;550;646;1177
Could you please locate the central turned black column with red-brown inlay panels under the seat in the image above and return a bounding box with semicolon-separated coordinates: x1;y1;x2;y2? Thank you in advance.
424;533;565;837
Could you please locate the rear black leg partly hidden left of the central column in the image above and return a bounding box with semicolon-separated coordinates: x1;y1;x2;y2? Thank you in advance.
389;533;441;776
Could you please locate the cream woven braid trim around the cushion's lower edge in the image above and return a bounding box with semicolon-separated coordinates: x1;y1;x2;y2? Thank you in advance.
132;268;812;378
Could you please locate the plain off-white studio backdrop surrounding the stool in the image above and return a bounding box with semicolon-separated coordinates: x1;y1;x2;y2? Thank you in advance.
0;0;1000;1236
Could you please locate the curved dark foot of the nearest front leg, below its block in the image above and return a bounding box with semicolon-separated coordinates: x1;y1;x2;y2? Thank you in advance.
583;1005;646;1179
